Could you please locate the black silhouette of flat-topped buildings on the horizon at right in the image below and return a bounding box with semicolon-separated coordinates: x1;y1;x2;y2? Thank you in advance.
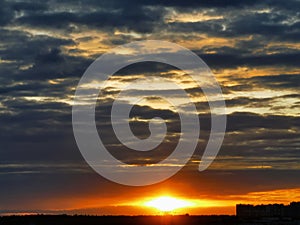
236;202;300;218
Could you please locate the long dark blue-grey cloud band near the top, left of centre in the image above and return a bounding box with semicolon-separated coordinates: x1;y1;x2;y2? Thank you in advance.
17;5;164;33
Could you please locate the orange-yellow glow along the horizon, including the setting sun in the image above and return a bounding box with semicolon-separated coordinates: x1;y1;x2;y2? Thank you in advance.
10;188;300;215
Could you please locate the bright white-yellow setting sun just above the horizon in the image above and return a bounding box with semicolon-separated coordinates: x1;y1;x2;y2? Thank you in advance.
144;196;194;212
